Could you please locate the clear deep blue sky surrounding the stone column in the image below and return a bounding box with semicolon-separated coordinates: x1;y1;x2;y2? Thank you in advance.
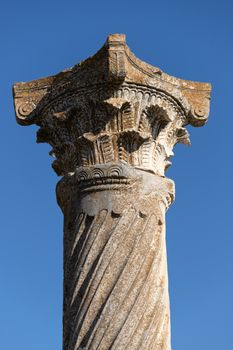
0;0;233;350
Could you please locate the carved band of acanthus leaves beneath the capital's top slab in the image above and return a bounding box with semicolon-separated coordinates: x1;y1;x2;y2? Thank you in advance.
32;94;193;175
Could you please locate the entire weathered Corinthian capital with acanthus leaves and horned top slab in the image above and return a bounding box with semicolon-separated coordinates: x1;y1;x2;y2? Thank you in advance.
13;34;210;176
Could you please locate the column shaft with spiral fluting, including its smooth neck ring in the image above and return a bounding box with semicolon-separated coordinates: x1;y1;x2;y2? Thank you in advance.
57;164;173;350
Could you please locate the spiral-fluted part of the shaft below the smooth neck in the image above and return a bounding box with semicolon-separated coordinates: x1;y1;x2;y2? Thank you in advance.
64;200;170;350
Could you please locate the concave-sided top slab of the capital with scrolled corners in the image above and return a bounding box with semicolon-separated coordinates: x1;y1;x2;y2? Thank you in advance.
13;34;211;126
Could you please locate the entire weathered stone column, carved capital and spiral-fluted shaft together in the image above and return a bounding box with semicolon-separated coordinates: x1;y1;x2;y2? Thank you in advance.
14;34;210;350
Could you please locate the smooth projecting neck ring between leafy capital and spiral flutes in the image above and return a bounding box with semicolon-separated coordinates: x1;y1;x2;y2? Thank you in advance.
57;163;175;212
